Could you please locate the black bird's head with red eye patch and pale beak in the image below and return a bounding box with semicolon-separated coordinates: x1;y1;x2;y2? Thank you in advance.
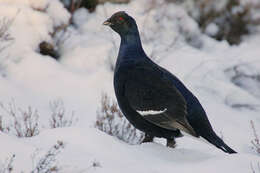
103;11;138;37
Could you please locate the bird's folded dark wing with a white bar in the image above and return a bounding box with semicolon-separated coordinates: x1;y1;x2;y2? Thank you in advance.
125;62;195;135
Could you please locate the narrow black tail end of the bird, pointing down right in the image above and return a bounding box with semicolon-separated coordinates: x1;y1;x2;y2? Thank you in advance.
202;133;237;154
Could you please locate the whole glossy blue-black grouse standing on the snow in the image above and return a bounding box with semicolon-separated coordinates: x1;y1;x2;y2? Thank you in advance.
103;11;237;154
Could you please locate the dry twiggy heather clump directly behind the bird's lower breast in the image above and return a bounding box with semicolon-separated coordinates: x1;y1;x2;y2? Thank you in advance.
95;94;144;144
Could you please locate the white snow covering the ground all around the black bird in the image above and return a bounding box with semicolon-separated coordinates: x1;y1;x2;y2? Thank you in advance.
0;0;260;173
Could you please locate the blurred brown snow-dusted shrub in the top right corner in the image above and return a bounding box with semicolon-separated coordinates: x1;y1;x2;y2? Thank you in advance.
186;0;260;44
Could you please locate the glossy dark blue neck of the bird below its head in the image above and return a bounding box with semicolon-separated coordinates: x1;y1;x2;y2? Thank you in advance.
118;31;146;59
